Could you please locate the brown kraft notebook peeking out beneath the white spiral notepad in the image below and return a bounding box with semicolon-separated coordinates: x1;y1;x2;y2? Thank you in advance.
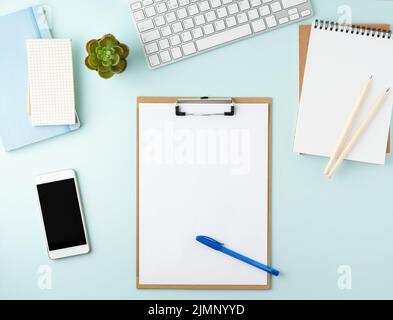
299;23;390;154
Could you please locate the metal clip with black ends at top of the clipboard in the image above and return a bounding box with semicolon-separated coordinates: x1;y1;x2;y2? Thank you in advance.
175;97;235;117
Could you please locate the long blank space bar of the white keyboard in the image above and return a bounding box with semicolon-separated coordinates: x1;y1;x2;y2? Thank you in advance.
196;24;251;51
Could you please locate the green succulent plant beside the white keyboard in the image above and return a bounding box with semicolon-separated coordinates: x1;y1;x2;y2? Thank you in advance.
85;34;130;79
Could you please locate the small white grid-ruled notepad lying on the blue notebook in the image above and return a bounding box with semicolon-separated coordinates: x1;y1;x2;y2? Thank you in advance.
27;39;76;126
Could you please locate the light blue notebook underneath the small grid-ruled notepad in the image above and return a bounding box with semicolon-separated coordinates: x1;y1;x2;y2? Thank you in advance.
0;7;80;151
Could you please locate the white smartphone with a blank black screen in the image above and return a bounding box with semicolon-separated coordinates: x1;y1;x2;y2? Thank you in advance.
36;170;90;259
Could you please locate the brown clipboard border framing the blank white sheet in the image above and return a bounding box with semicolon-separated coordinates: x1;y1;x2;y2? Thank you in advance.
136;97;273;290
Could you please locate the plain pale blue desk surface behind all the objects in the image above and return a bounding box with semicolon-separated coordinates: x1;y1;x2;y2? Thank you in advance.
0;0;393;299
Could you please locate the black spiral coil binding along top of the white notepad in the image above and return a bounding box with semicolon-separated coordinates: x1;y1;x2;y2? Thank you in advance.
313;20;393;39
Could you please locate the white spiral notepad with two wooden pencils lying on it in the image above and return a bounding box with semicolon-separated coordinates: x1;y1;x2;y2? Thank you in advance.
294;21;393;164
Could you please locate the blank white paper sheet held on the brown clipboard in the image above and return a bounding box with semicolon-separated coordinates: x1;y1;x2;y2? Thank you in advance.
139;103;269;285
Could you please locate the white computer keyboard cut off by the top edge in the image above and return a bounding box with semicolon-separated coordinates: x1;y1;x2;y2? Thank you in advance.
130;0;313;69
